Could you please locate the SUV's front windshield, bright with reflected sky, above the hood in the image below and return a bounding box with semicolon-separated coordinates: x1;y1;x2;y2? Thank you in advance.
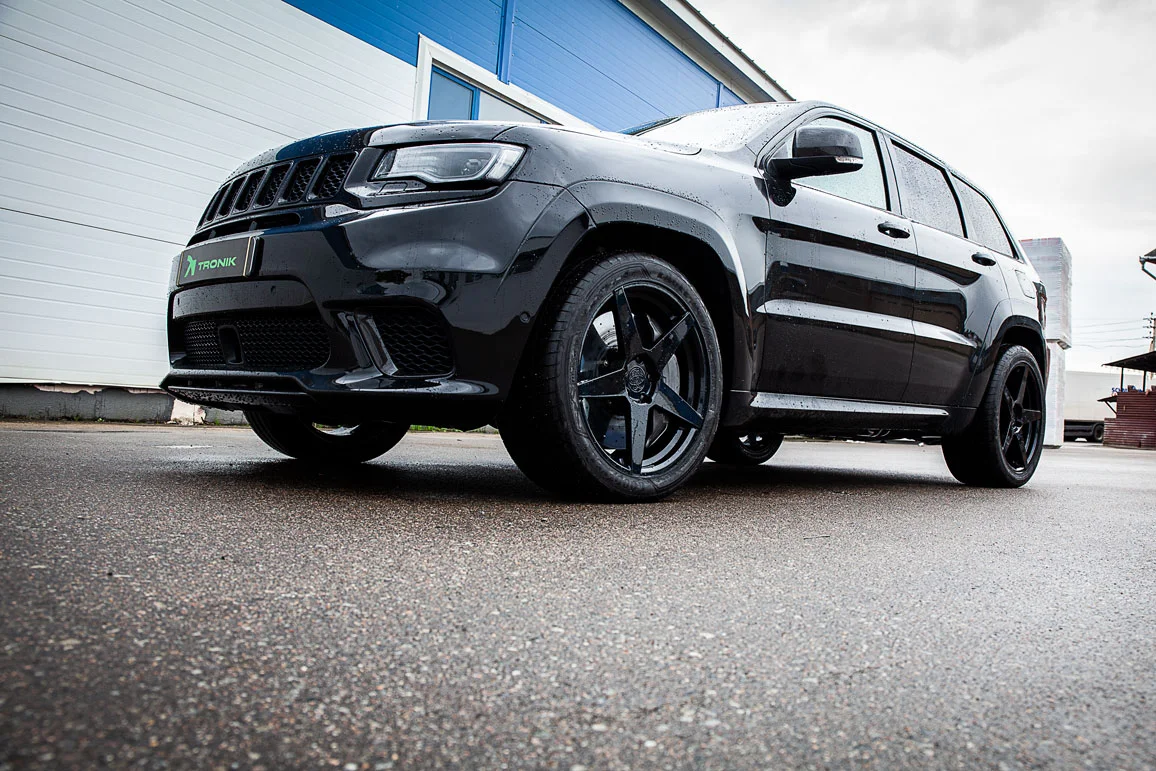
622;102;798;150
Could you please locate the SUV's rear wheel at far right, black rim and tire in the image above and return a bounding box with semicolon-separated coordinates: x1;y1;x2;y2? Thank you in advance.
943;346;1045;488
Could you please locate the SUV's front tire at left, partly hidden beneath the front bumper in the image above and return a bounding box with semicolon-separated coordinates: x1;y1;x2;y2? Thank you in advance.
245;409;409;466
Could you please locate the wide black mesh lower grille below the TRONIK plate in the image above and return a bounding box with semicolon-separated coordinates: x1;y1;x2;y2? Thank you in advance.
183;313;329;372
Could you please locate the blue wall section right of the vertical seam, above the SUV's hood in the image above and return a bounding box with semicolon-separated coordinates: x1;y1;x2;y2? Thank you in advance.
510;0;718;129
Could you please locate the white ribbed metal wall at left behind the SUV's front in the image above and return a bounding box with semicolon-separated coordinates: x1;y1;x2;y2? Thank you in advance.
0;0;416;387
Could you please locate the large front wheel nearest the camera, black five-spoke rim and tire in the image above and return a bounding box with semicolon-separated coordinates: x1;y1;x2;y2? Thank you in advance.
499;253;723;501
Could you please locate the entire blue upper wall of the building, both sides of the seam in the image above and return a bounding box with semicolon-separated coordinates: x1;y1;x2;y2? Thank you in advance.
286;0;758;129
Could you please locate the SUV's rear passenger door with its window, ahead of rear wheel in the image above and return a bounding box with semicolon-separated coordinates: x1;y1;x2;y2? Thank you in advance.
890;139;1006;406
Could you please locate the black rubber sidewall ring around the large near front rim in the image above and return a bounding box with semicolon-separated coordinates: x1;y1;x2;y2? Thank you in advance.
556;253;723;498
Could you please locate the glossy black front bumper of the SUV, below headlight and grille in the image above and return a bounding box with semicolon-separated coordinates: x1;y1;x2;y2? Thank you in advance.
161;181;590;428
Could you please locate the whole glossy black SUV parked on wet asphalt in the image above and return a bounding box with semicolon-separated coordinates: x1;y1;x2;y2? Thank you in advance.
163;102;1047;501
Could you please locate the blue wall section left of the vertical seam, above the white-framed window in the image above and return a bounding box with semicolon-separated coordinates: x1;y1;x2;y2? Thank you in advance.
286;0;502;72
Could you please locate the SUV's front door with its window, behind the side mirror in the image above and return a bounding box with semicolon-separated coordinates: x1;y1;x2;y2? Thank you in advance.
758;114;916;402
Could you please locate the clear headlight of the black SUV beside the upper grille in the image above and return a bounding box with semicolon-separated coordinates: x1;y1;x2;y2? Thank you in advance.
372;142;525;185
